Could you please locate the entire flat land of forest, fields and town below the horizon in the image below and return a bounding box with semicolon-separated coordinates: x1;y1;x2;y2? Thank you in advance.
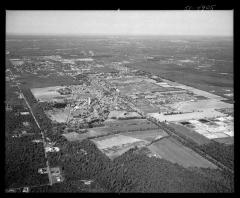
5;11;234;193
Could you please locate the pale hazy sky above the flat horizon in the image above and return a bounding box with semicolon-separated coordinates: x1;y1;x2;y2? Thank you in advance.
6;10;233;36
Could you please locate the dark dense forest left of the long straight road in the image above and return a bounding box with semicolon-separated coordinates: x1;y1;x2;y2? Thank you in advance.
5;98;49;188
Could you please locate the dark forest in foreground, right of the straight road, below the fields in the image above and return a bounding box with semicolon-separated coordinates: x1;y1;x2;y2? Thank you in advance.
57;140;230;192
